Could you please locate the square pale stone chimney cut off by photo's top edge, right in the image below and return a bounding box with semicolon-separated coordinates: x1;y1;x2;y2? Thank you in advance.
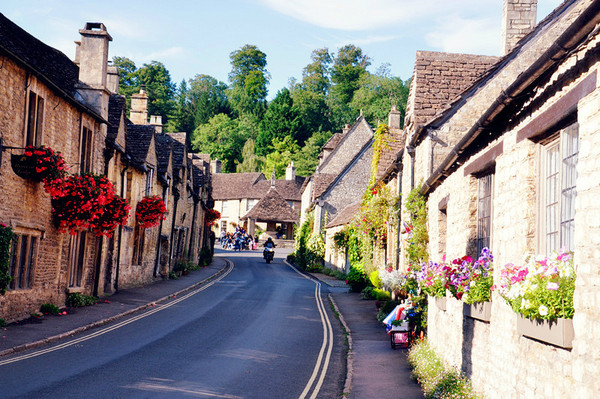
502;0;537;55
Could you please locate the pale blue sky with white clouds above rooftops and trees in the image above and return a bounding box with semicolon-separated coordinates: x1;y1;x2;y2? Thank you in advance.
0;0;562;98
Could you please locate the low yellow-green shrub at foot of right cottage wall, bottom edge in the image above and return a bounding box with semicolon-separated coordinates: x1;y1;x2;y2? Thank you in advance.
408;340;482;399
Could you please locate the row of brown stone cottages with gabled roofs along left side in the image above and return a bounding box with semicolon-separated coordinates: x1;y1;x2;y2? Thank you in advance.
0;14;211;322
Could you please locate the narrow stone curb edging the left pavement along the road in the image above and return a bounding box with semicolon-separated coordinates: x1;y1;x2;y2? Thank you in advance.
0;258;230;357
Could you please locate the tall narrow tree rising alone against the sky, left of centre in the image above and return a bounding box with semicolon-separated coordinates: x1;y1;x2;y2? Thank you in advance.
229;44;270;117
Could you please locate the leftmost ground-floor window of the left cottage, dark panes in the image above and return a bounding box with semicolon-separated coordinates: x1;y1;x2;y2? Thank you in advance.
9;233;39;290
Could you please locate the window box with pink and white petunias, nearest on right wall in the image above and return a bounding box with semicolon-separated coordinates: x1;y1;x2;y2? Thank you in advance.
497;251;576;348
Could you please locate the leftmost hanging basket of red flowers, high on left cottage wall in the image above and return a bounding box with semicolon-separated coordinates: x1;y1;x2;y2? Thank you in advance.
10;146;67;187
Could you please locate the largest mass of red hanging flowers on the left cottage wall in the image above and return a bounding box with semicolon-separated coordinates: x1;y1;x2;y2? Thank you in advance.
52;174;129;236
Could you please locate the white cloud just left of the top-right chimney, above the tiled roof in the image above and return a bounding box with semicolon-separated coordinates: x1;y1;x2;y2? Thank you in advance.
425;15;501;55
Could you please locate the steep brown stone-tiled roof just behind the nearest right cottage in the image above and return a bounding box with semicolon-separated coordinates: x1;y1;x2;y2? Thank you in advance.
406;51;500;126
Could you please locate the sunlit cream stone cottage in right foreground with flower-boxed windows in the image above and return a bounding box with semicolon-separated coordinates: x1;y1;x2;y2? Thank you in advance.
378;0;600;398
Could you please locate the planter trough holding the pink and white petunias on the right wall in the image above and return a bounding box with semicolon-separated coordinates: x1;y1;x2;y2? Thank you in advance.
517;316;575;349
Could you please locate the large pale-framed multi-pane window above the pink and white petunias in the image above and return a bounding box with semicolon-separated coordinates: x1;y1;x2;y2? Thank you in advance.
540;123;579;254
